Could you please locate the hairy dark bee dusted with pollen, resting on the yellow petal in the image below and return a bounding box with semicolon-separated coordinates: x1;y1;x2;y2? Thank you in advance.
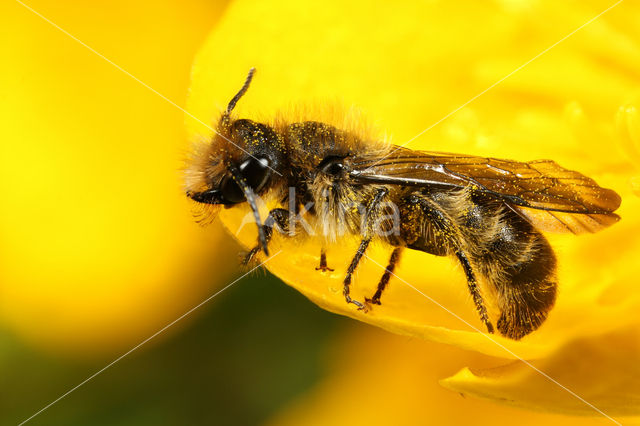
186;69;621;340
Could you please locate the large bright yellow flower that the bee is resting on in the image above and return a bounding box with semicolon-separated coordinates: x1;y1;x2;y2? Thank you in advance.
188;0;640;424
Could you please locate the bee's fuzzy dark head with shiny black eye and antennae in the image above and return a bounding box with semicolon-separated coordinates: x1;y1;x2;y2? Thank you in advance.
186;68;284;253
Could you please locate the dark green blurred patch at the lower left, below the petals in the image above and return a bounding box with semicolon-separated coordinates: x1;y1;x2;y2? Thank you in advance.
0;273;349;425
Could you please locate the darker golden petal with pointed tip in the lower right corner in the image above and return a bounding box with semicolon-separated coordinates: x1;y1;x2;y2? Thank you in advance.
440;324;640;416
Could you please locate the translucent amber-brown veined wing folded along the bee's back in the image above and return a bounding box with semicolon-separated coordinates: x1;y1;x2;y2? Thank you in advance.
350;147;620;233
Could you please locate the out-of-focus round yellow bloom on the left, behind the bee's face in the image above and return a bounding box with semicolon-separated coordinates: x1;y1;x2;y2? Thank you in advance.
0;1;235;355
